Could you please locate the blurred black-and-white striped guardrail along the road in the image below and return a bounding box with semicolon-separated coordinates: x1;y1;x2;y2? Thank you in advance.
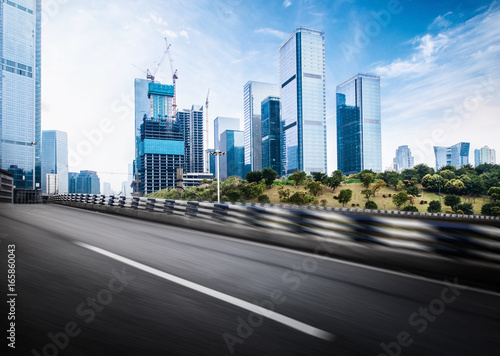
49;194;500;264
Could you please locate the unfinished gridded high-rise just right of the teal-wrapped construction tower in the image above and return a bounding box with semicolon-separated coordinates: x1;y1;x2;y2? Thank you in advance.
177;105;204;173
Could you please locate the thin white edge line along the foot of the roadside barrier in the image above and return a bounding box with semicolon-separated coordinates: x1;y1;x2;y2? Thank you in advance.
53;205;500;297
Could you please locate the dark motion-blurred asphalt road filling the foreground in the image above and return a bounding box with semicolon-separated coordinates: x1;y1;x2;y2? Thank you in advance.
0;204;500;356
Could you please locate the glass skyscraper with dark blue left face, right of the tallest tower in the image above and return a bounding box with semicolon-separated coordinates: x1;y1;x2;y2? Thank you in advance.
337;74;382;175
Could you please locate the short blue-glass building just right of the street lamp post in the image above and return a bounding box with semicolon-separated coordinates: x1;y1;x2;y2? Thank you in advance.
220;130;245;180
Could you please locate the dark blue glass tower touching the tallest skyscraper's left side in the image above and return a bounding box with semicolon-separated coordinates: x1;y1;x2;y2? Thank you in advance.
261;96;283;177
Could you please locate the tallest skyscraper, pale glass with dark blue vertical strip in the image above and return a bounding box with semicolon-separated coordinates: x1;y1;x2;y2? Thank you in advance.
279;28;327;174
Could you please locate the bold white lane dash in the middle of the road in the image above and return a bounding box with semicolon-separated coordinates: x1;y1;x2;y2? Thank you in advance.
75;242;335;341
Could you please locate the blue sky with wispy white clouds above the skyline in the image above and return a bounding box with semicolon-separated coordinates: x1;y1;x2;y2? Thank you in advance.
42;0;500;192
